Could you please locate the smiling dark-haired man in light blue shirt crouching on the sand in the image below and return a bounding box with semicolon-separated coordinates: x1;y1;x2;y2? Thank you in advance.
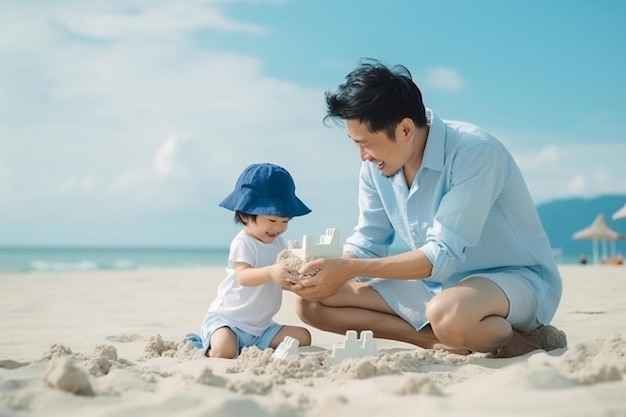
295;60;565;357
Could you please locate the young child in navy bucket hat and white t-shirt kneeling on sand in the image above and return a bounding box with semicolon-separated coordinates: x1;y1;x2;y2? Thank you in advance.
191;163;311;358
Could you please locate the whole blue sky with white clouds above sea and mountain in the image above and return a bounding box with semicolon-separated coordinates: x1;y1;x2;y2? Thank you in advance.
0;0;626;246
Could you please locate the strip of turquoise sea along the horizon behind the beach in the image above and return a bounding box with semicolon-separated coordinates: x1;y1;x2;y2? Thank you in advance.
0;247;578;273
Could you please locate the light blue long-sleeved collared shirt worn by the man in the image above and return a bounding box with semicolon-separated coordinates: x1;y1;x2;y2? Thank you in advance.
344;110;562;323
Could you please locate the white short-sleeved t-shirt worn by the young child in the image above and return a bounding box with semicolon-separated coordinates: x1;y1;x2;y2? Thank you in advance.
208;230;286;336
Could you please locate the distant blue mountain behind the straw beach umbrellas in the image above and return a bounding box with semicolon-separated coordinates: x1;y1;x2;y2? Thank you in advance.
537;194;626;258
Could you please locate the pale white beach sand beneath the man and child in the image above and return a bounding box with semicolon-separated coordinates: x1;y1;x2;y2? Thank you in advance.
0;266;626;417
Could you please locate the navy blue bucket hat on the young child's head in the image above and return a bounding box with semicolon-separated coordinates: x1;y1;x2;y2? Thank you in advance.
219;163;311;217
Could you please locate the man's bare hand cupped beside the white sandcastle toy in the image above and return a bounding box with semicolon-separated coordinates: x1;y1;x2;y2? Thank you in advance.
293;258;353;301
